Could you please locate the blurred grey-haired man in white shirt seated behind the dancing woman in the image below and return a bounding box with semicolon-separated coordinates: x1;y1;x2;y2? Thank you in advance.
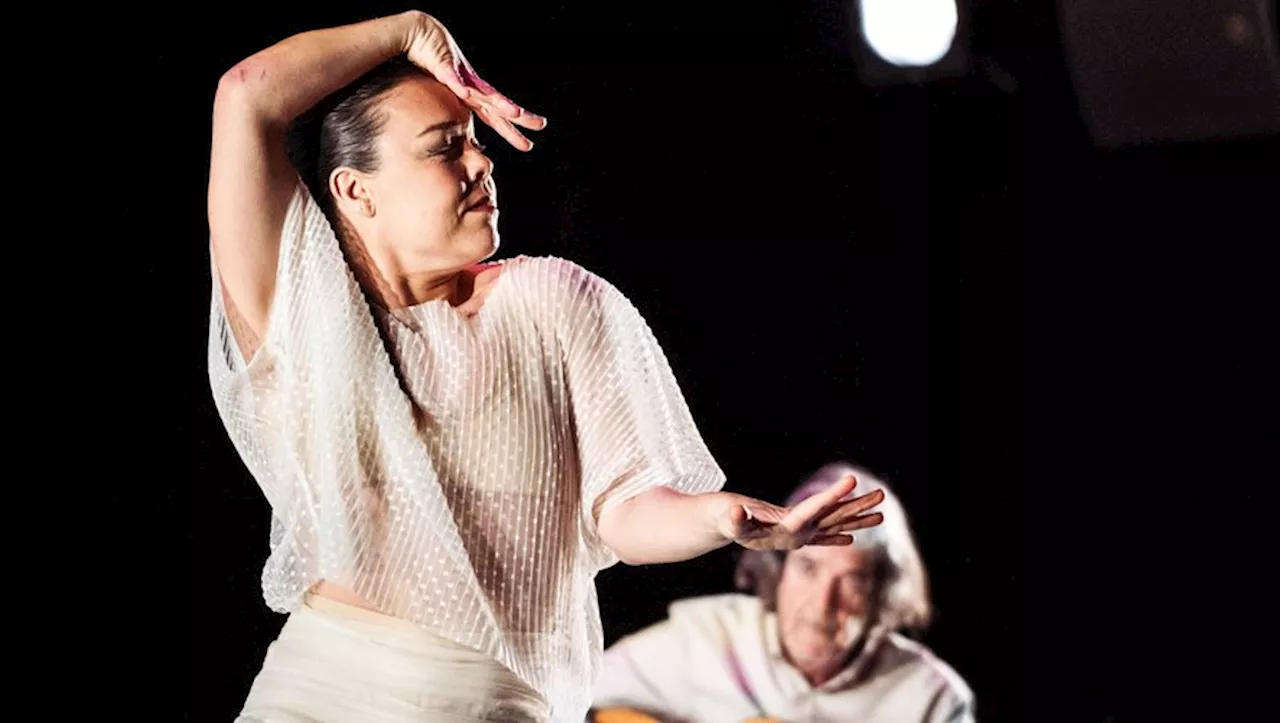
593;463;974;723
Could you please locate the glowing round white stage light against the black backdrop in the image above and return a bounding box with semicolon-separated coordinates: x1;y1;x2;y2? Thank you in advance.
858;0;959;68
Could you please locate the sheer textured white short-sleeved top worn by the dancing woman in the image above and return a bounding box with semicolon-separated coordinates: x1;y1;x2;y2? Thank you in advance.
209;182;724;720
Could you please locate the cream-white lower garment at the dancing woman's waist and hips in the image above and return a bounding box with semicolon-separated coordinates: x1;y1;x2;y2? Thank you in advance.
236;596;550;723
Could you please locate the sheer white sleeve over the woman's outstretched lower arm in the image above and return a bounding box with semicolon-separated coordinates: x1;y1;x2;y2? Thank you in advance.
564;262;724;568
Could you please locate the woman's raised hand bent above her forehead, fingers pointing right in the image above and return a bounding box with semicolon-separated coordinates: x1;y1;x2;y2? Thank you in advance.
404;10;547;151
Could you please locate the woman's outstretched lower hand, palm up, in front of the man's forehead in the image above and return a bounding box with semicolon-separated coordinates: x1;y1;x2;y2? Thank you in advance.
717;475;884;550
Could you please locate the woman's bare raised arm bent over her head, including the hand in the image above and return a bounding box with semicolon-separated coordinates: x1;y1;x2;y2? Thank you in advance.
209;10;545;357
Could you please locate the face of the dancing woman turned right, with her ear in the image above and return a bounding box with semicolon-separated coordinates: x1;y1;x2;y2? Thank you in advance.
330;75;498;275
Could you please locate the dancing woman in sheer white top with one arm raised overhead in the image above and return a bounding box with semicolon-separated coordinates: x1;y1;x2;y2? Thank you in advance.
209;12;881;722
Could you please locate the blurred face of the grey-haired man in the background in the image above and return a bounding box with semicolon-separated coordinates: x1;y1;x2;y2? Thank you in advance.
777;545;874;674
